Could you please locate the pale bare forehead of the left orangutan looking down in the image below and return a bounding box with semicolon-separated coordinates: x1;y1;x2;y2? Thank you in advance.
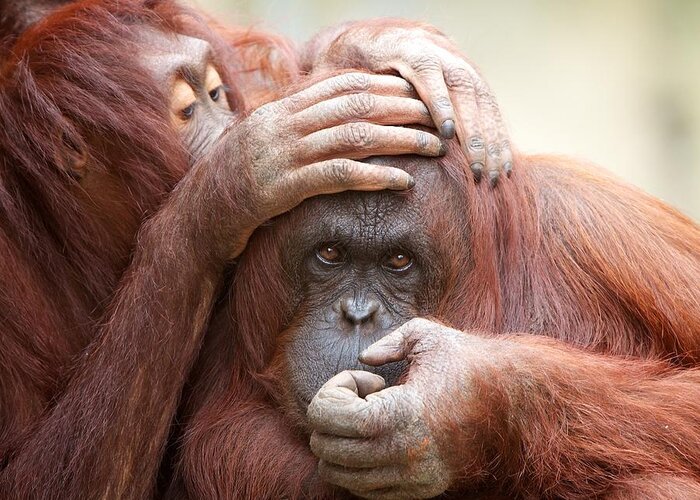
138;29;211;86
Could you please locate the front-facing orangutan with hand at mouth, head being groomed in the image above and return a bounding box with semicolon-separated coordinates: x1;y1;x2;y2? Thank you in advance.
173;131;700;499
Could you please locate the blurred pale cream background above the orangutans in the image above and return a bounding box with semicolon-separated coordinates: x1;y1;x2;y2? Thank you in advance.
189;0;700;221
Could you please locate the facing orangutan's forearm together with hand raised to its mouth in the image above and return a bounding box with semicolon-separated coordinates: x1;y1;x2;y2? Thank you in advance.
309;320;700;498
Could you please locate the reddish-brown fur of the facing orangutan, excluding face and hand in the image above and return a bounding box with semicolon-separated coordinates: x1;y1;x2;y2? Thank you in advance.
175;143;700;498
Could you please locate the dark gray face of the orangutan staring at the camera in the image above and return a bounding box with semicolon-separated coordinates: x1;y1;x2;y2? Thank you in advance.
276;166;442;424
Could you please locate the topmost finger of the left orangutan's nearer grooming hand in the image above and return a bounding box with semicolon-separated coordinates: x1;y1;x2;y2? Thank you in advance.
279;73;417;113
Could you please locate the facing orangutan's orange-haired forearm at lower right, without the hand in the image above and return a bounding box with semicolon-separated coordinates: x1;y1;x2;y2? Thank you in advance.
486;336;700;497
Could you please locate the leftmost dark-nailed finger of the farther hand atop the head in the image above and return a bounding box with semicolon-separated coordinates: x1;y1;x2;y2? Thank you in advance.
396;55;455;139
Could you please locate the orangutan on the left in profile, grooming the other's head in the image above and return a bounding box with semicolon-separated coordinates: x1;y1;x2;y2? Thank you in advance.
0;1;516;498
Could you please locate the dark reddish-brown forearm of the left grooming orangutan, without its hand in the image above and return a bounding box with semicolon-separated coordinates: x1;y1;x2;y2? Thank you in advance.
0;128;249;498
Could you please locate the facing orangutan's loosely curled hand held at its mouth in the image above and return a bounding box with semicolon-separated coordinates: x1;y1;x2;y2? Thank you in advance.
307;319;498;499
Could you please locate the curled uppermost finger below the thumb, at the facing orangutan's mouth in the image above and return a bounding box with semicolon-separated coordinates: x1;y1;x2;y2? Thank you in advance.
306;377;404;438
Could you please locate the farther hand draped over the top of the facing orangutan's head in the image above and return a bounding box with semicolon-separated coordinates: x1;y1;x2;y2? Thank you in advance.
307;19;513;185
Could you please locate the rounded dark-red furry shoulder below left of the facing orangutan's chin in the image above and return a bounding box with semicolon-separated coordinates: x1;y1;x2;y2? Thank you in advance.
175;370;341;499
